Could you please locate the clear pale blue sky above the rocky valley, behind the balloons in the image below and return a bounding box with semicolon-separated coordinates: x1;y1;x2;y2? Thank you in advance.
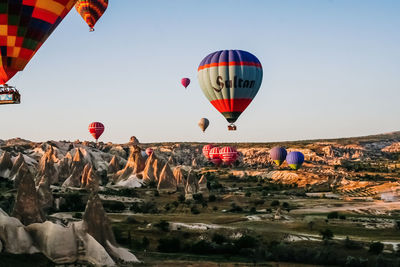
0;0;400;143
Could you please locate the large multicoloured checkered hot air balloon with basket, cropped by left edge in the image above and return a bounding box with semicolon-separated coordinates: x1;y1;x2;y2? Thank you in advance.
0;0;76;103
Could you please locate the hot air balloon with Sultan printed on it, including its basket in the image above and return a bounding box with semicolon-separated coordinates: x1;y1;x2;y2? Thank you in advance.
197;50;263;130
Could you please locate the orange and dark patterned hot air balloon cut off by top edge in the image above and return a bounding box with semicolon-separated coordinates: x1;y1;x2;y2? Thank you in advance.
75;0;108;32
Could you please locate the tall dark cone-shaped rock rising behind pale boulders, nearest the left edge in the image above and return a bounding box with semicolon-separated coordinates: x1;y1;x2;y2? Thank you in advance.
12;164;45;225
